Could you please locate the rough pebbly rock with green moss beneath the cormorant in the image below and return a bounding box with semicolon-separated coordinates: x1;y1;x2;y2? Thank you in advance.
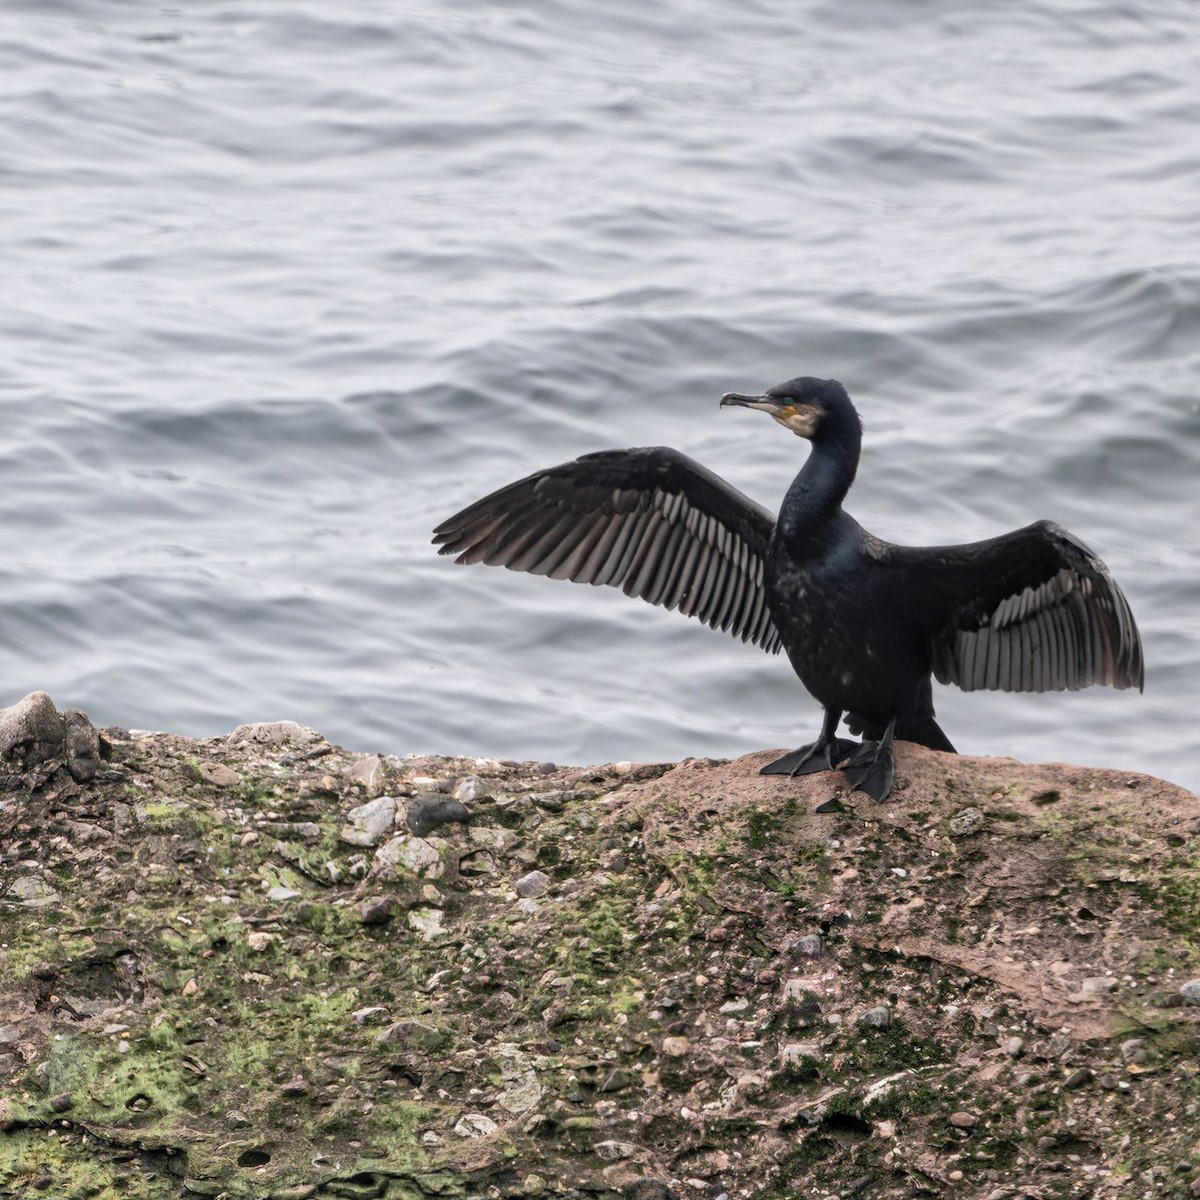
0;700;1200;1200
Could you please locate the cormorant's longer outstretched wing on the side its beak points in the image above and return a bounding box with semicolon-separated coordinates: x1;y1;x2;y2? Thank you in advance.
433;446;781;654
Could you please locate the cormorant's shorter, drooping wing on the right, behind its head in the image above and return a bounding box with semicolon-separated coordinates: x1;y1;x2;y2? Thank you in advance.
912;521;1145;691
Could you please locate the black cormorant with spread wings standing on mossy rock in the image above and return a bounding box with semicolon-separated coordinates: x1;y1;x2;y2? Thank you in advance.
433;378;1144;800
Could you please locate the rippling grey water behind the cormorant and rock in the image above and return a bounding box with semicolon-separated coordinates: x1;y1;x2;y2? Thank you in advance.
0;0;1200;788
